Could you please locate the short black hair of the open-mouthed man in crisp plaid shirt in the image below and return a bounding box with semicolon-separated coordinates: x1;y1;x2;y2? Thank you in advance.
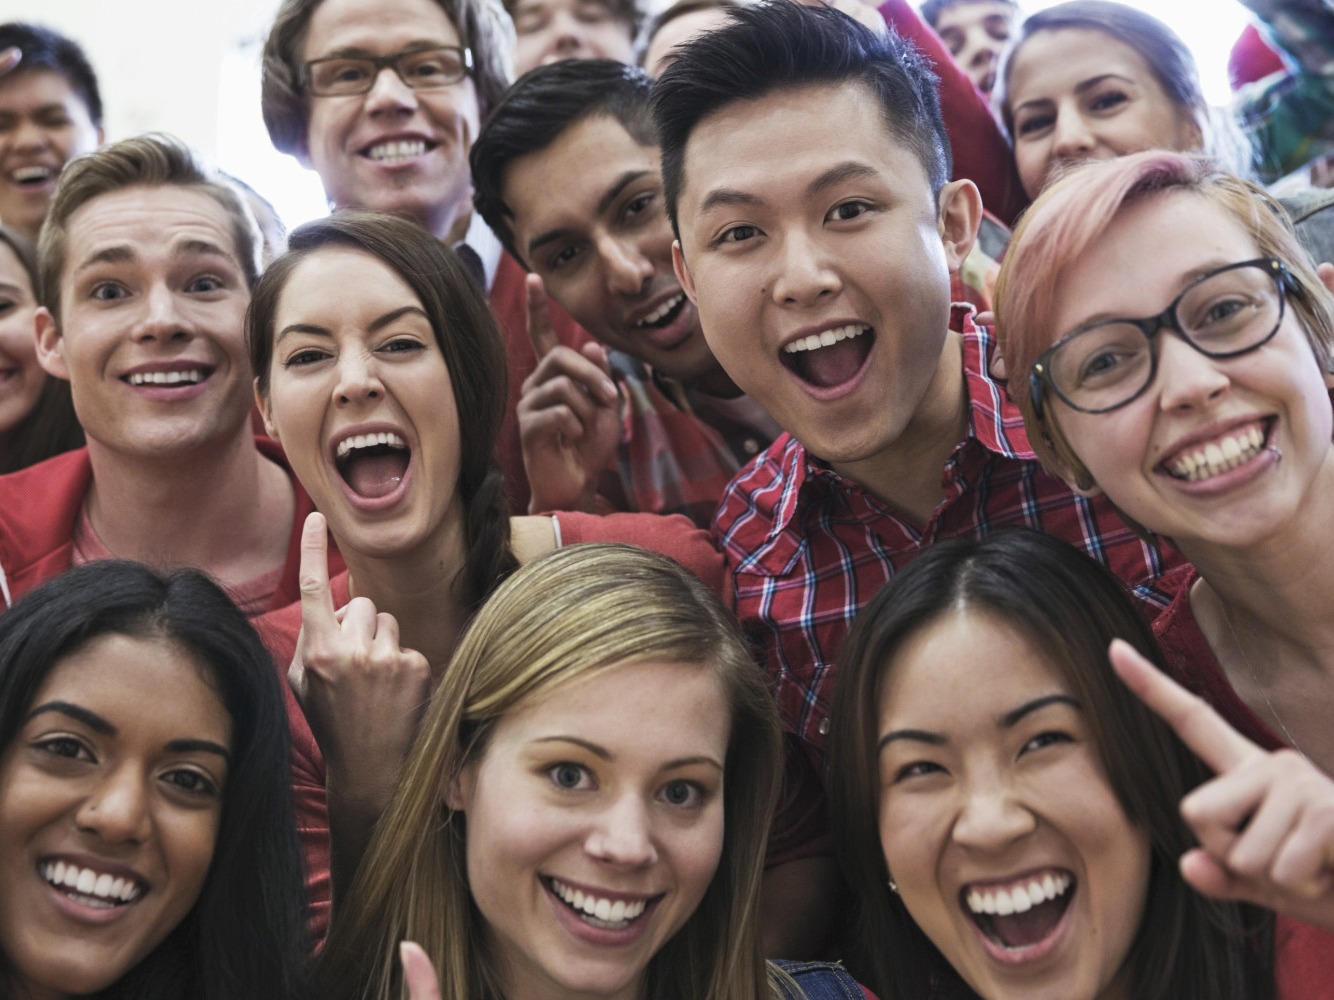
652;0;954;237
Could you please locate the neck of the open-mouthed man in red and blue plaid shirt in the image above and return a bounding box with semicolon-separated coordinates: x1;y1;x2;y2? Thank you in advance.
834;331;968;525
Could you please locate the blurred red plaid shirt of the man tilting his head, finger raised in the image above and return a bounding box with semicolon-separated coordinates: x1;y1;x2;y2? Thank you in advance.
599;352;768;528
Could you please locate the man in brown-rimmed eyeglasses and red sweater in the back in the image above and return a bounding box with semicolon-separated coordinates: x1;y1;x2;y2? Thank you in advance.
261;0;588;509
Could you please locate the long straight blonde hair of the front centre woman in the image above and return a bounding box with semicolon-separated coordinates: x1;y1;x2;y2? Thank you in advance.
316;545;780;1000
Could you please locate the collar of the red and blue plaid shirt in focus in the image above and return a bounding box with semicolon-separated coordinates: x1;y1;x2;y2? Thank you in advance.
736;312;1037;576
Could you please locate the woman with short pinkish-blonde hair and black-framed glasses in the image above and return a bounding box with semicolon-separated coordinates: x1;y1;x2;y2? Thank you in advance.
998;152;1334;772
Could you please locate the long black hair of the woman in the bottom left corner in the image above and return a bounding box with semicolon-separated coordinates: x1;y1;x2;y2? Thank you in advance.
0;560;307;1000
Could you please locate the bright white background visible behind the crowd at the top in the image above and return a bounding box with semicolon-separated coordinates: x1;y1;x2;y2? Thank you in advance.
0;0;1246;227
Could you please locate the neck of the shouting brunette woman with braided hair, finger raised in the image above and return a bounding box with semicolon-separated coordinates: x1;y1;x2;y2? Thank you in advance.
342;496;471;680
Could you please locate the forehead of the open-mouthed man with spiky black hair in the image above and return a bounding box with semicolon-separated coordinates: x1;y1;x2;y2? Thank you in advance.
680;81;934;213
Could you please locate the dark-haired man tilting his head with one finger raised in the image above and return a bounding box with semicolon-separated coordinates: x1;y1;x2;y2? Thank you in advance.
472;59;778;527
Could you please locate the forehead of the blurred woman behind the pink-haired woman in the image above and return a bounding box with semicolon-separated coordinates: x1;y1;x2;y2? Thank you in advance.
1009;28;1166;107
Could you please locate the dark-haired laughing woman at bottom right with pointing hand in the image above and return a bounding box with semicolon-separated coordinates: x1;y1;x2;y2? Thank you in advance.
830;531;1334;1000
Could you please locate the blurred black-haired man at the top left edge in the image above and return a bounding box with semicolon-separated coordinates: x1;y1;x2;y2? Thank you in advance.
0;21;103;243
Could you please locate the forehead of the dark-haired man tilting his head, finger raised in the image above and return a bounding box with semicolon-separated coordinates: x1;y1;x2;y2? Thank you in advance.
502;113;662;236
